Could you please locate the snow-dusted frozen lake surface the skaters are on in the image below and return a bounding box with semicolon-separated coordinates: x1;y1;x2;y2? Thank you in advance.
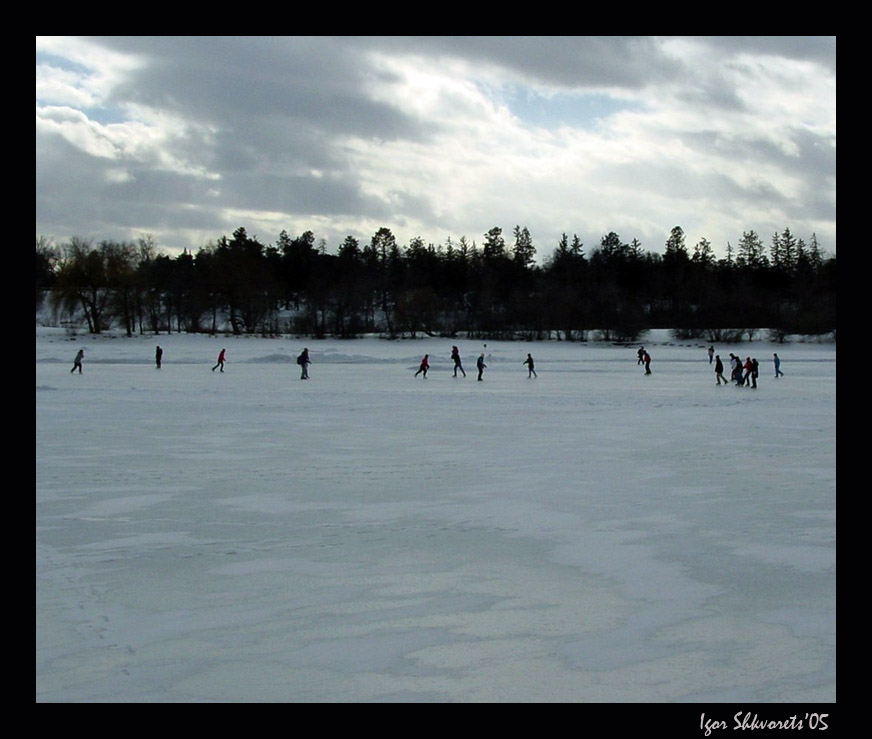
36;328;836;703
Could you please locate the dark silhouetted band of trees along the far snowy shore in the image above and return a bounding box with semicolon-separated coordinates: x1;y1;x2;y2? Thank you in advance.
36;226;836;341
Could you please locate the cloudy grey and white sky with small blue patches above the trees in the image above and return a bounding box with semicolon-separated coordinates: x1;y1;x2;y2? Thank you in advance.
36;36;836;261
